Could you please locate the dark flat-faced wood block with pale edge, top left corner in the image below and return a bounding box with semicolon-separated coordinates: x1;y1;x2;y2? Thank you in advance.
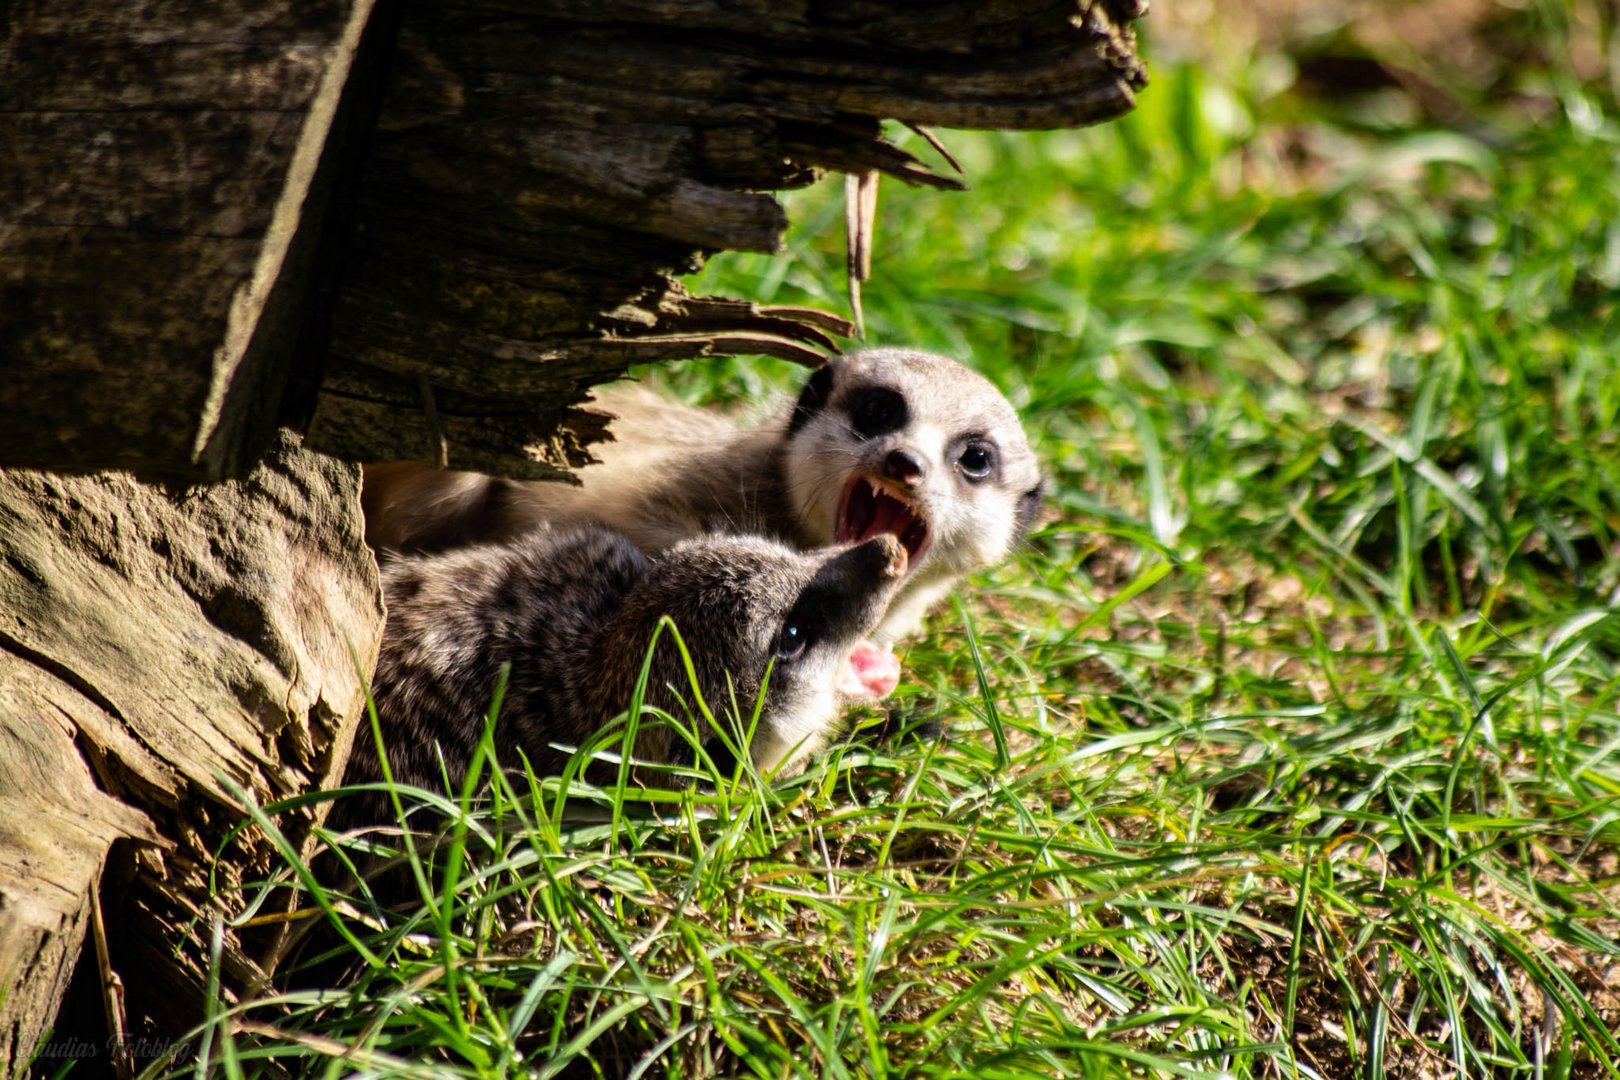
0;0;386;479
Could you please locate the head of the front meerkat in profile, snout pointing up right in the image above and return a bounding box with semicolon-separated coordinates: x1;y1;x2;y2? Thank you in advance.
606;536;907;769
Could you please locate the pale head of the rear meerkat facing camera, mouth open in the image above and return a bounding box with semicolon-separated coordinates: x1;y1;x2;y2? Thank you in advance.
784;348;1042;634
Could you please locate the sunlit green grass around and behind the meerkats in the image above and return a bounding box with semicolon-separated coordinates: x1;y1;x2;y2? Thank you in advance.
145;3;1620;1077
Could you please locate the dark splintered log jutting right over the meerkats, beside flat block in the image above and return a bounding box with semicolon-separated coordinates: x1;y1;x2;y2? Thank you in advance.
309;0;1142;476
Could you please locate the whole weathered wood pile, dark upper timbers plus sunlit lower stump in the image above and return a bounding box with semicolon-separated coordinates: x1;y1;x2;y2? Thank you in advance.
0;0;1144;1074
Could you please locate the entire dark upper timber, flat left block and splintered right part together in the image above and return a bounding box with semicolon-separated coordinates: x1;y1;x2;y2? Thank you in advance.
0;0;1142;481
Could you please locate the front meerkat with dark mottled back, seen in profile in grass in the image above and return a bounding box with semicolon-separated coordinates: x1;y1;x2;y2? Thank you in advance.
334;526;906;827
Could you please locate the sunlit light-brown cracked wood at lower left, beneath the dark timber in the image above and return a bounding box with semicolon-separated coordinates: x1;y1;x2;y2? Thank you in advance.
0;437;382;1075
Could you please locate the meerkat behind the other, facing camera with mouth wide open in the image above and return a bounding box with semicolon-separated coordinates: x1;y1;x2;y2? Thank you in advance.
363;348;1043;644
